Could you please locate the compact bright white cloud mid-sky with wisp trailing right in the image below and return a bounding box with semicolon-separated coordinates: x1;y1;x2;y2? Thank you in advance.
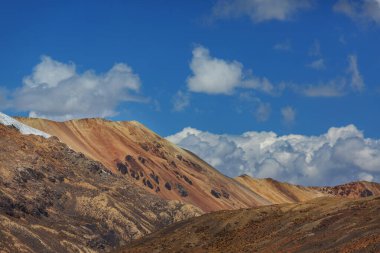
187;46;274;95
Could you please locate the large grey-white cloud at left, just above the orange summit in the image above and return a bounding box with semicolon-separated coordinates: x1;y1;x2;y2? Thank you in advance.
11;56;141;120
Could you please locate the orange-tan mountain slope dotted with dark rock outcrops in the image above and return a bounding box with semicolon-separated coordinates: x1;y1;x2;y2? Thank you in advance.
19;118;271;212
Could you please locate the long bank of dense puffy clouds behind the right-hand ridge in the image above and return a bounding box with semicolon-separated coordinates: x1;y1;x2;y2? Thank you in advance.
167;125;380;185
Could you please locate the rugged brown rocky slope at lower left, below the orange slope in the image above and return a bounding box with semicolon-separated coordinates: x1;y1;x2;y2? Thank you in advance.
0;124;202;252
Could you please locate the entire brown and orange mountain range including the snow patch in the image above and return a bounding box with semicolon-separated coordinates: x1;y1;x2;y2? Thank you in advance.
0;113;380;252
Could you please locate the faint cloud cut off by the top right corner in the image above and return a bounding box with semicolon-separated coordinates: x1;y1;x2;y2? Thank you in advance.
333;0;380;24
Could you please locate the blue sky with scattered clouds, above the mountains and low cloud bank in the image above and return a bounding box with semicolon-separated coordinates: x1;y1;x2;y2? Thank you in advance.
0;0;380;139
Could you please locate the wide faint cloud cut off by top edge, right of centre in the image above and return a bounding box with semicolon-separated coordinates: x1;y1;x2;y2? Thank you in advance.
213;0;312;23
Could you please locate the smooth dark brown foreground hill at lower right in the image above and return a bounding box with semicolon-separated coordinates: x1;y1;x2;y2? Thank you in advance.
120;197;380;253
